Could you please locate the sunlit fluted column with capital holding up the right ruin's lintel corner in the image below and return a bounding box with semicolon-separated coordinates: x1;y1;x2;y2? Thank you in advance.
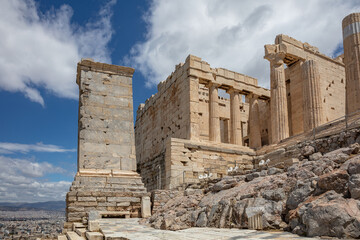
267;53;289;143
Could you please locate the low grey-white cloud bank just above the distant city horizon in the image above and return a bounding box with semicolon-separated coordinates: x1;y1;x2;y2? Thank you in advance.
0;156;71;202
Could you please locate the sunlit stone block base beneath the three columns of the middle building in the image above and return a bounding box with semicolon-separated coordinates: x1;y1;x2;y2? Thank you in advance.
163;138;255;189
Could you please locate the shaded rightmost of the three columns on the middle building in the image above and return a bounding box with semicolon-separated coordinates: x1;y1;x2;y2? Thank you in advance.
248;94;261;149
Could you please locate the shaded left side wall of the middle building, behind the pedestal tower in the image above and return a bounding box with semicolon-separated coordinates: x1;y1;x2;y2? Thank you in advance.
135;62;190;190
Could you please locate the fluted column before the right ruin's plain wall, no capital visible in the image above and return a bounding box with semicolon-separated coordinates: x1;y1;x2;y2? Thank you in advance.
301;60;325;132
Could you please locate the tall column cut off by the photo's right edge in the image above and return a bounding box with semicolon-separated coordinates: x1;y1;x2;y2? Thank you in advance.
342;13;360;114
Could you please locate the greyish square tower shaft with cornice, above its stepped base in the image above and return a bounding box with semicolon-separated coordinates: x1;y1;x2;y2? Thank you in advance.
77;60;136;170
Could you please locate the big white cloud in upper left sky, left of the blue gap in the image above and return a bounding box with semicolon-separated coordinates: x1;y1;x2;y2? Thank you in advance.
0;0;115;105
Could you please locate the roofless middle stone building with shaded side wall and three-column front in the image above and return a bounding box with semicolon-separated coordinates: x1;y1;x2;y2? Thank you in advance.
135;55;269;191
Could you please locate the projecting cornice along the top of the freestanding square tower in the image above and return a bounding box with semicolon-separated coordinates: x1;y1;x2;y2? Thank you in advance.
76;58;135;84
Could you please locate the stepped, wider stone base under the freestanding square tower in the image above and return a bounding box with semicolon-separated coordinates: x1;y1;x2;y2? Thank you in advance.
66;170;150;222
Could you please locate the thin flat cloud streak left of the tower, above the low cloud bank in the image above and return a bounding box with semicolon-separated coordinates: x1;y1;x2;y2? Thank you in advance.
0;142;76;154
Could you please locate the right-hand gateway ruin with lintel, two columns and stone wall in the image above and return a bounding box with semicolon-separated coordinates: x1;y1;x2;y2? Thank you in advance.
264;34;345;144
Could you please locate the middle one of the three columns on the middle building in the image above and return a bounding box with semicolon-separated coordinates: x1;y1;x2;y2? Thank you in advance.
228;88;243;145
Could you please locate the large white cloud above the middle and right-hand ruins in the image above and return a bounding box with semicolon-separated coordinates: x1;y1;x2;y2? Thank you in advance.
128;0;360;87
